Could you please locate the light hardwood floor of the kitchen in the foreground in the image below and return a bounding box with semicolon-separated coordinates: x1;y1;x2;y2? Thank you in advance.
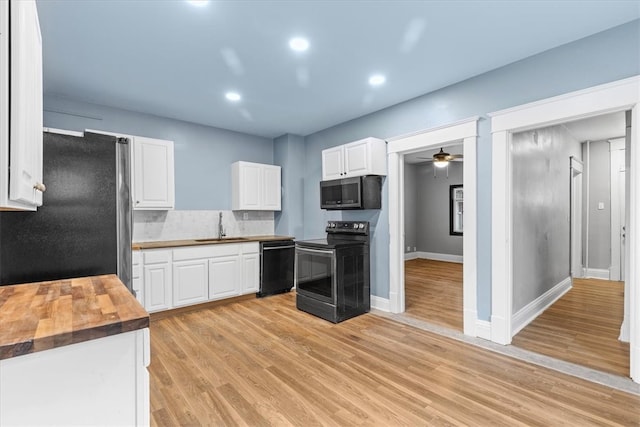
150;293;640;426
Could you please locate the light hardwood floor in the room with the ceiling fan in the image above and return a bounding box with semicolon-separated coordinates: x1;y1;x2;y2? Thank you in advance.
404;259;462;331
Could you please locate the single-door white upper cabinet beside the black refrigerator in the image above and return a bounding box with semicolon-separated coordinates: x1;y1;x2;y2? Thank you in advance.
132;136;175;210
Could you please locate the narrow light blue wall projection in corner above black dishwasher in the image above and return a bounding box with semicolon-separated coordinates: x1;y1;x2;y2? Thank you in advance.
273;134;305;239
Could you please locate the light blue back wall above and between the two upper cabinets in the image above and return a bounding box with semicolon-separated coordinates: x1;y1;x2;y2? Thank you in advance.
44;96;273;210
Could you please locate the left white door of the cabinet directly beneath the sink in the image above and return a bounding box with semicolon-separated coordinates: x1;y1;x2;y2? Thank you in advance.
173;259;209;307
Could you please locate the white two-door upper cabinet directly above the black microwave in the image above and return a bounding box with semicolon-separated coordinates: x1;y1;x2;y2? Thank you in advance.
322;138;387;181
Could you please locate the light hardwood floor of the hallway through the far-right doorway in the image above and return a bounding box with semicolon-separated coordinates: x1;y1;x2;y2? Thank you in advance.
513;279;629;377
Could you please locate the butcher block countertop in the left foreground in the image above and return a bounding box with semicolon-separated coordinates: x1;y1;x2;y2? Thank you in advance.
0;274;149;360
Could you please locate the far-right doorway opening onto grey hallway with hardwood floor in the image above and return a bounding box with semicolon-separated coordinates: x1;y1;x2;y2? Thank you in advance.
511;111;629;377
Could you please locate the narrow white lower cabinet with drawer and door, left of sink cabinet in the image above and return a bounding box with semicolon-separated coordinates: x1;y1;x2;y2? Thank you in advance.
144;249;173;313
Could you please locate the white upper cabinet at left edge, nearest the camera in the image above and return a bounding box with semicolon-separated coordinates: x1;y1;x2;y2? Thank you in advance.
0;0;45;211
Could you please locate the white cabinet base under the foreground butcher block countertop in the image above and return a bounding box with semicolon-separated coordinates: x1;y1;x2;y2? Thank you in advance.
0;328;150;426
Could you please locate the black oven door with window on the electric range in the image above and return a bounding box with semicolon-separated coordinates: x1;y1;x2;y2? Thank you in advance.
296;246;337;304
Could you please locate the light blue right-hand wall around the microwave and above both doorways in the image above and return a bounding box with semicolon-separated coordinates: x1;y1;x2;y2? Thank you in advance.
304;20;640;320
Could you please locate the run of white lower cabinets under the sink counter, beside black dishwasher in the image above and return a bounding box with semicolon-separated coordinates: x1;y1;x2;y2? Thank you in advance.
138;242;260;312
